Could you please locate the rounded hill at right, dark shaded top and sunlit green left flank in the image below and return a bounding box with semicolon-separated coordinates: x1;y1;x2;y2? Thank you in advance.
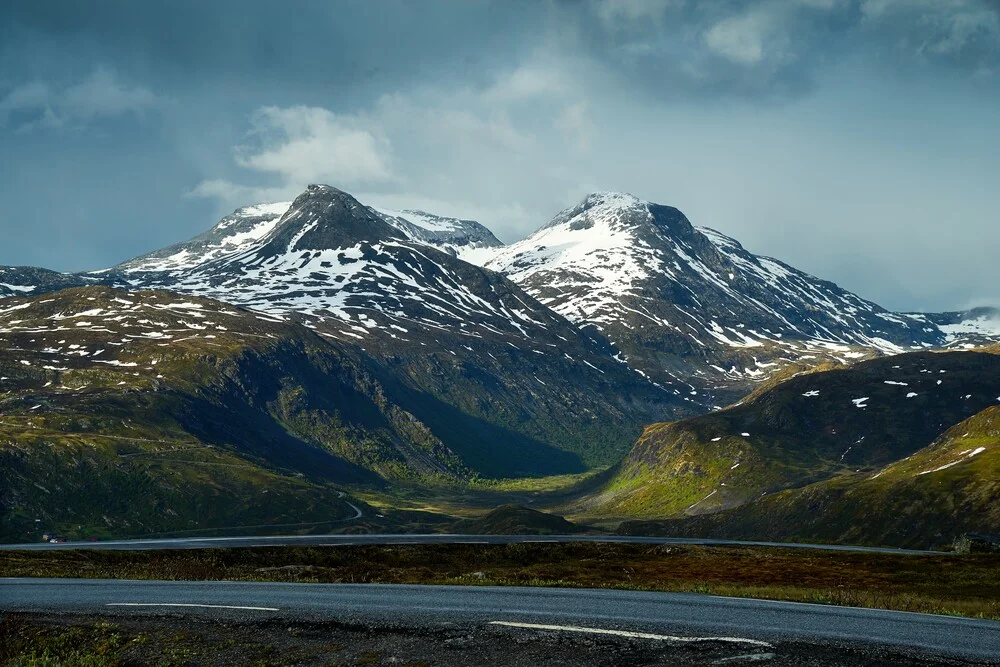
579;351;1000;517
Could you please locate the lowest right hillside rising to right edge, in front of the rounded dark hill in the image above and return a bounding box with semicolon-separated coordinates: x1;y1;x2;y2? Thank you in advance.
619;405;1000;548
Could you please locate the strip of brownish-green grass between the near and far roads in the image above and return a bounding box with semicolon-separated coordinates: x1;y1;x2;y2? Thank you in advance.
0;543;1000;620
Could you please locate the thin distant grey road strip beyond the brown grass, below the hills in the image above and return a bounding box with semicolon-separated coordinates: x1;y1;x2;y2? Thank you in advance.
0;534;943;554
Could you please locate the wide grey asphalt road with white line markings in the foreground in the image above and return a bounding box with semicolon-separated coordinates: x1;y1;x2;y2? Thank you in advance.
0;579;1000;660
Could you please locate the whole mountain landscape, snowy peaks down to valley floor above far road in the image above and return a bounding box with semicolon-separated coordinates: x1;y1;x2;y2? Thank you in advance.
0;185;1000;548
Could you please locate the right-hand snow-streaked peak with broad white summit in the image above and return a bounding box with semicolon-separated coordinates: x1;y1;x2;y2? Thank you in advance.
485;193;1000;405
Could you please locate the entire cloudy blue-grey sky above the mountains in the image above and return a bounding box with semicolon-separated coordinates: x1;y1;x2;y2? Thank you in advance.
0;0;1000;310
